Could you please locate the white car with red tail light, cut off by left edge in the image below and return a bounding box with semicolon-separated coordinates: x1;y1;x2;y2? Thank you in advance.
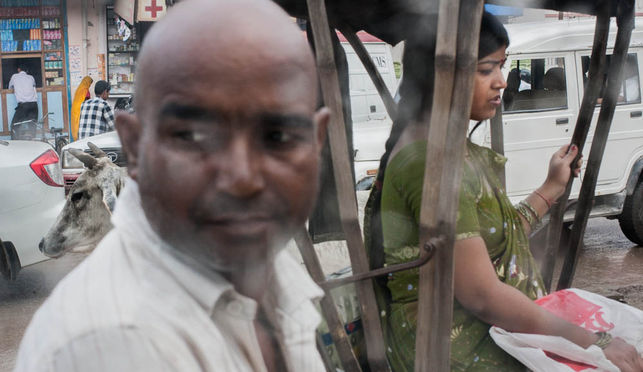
0;141;65;280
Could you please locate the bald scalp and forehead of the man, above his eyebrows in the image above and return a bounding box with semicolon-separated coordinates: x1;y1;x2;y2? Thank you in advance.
136;0;317;120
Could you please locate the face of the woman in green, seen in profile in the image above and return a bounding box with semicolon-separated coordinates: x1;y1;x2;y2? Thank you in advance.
471;46;507;121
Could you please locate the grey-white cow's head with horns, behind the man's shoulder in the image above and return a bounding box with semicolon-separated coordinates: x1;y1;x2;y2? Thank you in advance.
39;142;126;257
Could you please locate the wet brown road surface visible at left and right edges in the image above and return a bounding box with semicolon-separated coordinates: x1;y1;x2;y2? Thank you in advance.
0;218;643;372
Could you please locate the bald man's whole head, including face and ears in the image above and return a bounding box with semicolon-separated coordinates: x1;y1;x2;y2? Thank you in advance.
116;0;330;271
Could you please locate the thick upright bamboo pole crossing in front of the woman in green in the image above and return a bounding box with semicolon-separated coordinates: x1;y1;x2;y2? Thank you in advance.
415;0;484;371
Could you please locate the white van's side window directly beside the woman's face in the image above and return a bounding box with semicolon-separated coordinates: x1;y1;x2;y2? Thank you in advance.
502;57;567;112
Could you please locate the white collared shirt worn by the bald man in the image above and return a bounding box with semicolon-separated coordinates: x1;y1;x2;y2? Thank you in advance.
16;180;325;372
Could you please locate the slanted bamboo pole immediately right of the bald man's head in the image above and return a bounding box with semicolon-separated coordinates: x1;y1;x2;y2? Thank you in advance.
307;0;389;372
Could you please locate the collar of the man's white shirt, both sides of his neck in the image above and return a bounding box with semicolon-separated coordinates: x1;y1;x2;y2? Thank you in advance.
112;182;324;314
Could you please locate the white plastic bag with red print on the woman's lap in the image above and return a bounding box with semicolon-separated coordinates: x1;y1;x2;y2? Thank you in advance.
489;288;643;372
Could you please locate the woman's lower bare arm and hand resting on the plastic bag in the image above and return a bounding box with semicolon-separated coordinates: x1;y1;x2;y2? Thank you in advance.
454;237;643;372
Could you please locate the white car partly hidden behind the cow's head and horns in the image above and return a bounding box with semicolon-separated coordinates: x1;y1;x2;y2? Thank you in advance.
61;131;127;192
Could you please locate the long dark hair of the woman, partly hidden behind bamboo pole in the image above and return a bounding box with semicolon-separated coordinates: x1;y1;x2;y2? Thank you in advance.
366;11;509;268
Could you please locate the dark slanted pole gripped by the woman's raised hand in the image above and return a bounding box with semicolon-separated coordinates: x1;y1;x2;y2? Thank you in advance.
541;0;610;290
